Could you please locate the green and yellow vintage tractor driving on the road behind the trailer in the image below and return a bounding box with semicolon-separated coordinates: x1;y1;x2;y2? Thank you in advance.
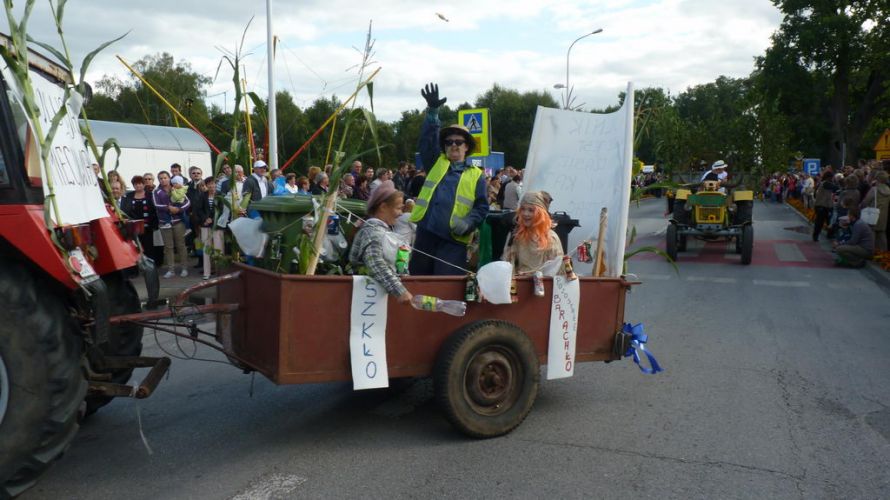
666;181;754;265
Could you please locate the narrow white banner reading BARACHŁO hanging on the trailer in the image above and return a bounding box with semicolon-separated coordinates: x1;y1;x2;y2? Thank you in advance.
547;276;581;380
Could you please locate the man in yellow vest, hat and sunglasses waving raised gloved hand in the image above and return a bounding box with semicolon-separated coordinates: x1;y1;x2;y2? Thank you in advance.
409;83;488;276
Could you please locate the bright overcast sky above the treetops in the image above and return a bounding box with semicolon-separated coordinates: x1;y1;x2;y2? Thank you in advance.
10;0;781;121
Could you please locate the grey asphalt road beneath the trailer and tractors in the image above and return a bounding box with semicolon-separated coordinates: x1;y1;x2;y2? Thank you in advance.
22;200;890;500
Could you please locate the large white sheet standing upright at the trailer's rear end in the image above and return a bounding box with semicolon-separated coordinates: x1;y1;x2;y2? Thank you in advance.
523;83;634;276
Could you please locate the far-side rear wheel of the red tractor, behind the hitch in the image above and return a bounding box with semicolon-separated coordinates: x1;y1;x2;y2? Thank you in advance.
86;273;143;415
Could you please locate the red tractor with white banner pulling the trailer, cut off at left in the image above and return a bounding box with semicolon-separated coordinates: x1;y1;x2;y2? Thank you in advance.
0;35;169;498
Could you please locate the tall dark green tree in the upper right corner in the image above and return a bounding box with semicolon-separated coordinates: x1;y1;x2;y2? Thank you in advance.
758;0;890;165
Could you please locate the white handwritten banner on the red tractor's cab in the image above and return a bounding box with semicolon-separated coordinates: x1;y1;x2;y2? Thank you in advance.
3;65;108;225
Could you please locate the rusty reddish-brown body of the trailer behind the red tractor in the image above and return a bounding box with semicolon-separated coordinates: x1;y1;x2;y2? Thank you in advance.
218;265;629;384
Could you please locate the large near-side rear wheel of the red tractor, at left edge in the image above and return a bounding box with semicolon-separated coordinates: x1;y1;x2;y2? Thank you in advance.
0;263;87;498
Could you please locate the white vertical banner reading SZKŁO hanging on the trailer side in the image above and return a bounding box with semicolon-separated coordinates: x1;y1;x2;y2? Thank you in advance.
349;276;389;391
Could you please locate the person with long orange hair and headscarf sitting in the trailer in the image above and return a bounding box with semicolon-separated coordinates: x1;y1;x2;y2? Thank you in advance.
502;191;563;274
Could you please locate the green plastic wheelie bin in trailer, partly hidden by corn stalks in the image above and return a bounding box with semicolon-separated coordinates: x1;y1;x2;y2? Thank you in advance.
250;195;366;273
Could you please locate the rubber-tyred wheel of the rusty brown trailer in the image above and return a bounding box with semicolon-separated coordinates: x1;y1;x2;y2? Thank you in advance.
434;320;540;438
